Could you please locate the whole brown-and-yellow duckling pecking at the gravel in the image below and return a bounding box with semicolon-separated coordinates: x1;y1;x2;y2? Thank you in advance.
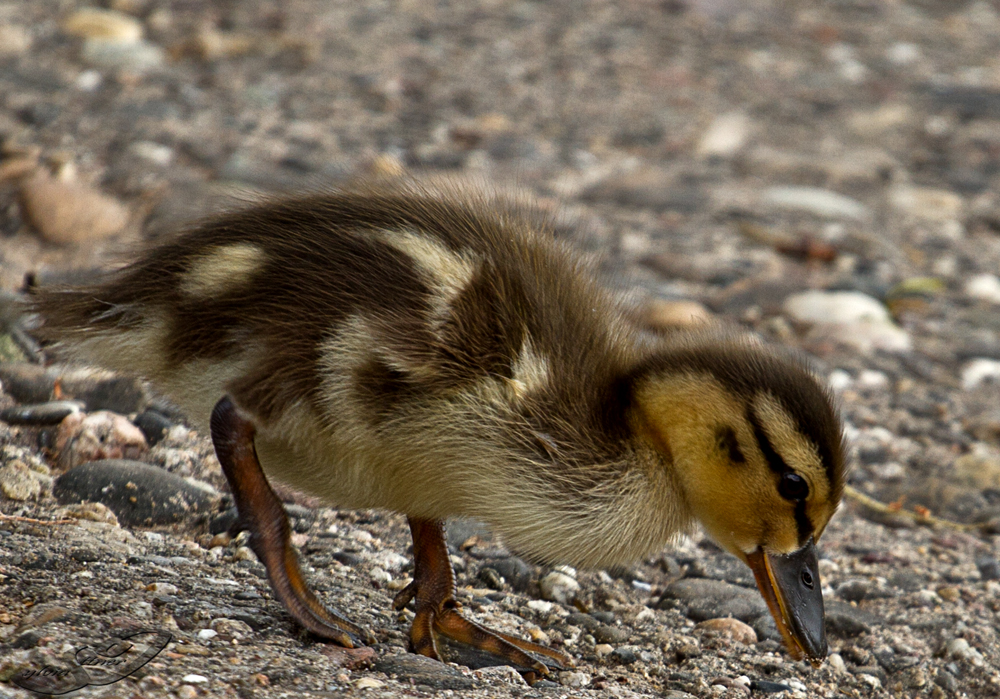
34;184;844;678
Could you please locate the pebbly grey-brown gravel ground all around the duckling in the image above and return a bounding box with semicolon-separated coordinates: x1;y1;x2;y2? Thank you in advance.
0;0;1000;699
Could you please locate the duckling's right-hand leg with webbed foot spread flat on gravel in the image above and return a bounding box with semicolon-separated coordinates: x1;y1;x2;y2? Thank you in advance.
392;517;573;682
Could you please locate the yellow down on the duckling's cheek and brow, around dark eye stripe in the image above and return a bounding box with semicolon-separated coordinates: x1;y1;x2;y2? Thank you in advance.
633;373;830;553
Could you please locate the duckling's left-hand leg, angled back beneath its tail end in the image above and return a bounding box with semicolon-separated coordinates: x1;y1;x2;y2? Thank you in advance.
211;397;371;648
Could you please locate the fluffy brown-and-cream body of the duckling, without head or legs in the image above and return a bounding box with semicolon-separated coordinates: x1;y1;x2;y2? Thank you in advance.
31;190;687;564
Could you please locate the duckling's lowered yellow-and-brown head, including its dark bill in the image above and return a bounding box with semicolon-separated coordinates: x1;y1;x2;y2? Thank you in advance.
633;336;844;664
